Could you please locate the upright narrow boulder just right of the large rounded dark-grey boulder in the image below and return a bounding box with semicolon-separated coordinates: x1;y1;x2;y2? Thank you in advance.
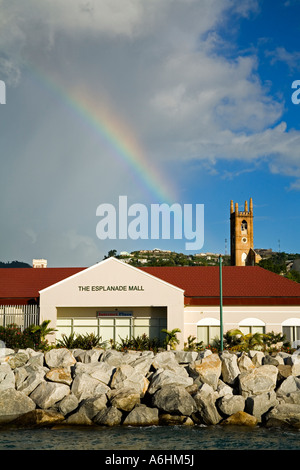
194;384;222;425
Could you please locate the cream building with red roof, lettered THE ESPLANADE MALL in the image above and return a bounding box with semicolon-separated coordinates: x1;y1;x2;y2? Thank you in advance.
0;258;300;348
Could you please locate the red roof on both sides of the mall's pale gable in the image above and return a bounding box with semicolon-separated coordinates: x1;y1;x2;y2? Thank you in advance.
0;266;300;305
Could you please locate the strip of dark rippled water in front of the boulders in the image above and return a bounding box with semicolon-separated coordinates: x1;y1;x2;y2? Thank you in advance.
0;426;300;451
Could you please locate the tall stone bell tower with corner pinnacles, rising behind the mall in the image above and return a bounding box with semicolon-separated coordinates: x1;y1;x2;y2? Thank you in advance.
230;198;256;266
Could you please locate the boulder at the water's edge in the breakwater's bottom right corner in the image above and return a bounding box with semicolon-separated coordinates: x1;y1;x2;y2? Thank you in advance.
266;403;300;429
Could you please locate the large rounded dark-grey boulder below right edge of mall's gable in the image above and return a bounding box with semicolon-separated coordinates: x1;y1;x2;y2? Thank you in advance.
152;385;197;416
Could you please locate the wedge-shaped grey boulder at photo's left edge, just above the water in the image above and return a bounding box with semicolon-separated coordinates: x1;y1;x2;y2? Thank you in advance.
0;388;36;424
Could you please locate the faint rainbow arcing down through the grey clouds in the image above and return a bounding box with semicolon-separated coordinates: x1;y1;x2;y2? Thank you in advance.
31;67;176;204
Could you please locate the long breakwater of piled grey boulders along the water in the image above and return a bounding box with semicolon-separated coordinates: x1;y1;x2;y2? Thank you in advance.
0;348;300;429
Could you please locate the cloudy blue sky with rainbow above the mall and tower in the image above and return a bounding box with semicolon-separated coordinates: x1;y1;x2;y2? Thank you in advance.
0;0;300;267
